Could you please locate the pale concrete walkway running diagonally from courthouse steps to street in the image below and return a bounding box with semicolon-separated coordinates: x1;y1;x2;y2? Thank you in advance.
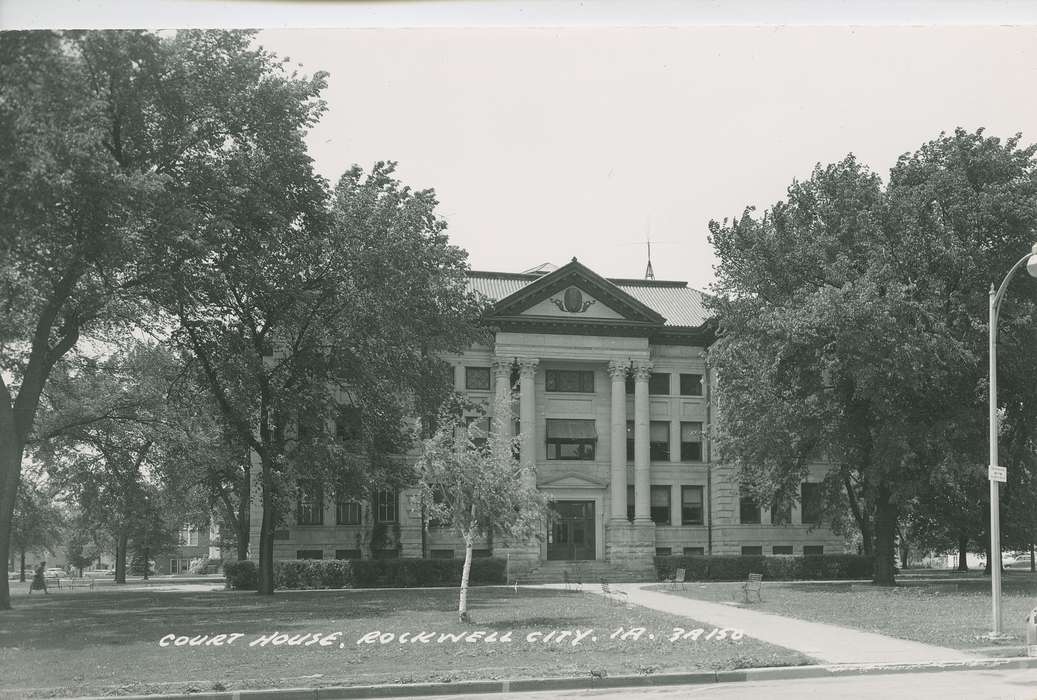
586;584;981;664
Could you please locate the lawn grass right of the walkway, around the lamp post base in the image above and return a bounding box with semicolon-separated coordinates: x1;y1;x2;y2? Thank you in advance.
657;571;1037;655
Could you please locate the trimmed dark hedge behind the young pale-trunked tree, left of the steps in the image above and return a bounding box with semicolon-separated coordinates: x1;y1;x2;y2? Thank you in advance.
223;557;506;590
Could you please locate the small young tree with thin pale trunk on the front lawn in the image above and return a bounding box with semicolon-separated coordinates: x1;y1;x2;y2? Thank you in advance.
416;397;548;622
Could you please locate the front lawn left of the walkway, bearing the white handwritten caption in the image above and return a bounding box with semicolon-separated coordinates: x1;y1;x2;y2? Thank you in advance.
0;587;810;698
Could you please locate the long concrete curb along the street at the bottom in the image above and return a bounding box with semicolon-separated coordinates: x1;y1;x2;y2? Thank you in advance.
71;656;1037;700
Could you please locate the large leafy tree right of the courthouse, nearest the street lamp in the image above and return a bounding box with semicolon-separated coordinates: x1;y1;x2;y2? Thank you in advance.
708;131;1037;585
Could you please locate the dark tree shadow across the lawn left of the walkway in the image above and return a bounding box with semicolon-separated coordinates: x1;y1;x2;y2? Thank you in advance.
0;588;580;650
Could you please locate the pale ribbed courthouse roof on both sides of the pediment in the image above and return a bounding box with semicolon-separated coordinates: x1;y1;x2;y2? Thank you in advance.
468;271;709;328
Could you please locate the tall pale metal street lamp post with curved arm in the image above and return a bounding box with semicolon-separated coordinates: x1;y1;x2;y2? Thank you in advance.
987;243;1037;637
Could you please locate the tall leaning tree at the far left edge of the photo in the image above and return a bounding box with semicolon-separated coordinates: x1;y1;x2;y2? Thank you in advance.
0;31;324;609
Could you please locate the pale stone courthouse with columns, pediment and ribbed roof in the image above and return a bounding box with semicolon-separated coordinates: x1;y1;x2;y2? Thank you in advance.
252;258;844;569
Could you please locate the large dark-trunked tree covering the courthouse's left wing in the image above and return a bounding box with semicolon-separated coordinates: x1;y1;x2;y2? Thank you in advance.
162;163;481;594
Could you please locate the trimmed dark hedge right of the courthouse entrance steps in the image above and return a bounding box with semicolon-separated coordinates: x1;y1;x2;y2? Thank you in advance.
655;554;873;581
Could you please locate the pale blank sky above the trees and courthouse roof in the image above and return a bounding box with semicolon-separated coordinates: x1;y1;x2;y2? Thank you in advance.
6;0;1037;289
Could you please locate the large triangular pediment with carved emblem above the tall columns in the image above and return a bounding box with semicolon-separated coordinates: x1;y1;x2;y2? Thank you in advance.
488;258;666;327
